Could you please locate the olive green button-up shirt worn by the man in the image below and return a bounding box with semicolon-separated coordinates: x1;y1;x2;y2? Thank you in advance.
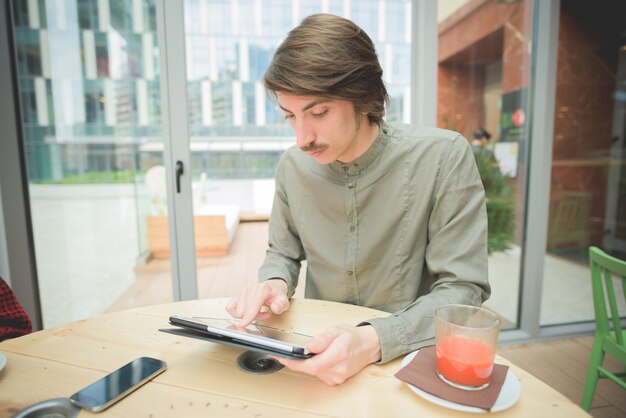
259;124;491;362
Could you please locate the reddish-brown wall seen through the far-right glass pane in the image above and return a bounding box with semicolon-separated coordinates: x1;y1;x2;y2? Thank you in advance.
550;4;618;245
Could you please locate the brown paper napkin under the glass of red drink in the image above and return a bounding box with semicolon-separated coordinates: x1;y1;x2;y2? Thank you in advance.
395;345;509;411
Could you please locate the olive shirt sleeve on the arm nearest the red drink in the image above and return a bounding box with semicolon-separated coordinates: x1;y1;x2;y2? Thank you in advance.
359;136;491;363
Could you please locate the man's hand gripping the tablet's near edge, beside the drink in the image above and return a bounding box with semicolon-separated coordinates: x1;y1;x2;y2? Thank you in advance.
275;325;380;385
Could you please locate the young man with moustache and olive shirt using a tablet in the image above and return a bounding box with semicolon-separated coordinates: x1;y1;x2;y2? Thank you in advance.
226;14;490;385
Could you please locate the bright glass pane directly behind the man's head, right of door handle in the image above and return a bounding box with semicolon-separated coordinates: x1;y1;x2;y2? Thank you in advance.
179;0;412;298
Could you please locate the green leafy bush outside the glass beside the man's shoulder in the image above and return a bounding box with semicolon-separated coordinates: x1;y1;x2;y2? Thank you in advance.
474;153;515;254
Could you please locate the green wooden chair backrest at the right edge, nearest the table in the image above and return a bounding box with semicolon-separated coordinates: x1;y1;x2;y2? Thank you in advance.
589;247;626;347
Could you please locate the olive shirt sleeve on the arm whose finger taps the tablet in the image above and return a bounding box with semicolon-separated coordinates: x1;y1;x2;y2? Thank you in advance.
259;158;305;297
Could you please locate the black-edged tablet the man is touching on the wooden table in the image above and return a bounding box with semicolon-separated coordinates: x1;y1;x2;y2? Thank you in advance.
161;315;313;359
